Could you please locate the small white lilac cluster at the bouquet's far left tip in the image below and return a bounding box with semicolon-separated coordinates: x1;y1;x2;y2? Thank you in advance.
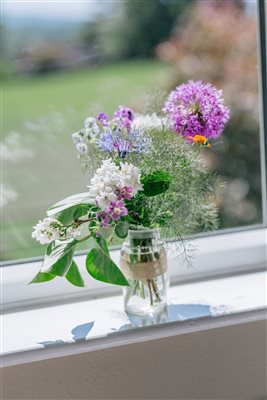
32;217;81;244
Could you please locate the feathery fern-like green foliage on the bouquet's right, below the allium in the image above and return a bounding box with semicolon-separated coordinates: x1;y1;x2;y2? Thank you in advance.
127;129;221;236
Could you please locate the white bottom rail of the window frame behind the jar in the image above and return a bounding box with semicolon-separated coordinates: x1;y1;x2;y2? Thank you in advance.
0;227;267;312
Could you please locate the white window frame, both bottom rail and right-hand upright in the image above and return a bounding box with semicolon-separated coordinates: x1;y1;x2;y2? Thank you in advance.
0;0;267;311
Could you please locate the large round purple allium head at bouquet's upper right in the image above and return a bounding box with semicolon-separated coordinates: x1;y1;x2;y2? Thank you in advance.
163;81;229;139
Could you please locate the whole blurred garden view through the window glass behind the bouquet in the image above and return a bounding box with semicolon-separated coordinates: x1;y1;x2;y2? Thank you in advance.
0;0;262;261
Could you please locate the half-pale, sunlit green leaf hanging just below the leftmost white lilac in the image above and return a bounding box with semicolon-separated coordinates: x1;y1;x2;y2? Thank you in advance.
41;239;78;276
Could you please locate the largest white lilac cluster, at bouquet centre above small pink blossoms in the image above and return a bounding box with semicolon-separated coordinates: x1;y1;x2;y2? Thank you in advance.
89;158;143;211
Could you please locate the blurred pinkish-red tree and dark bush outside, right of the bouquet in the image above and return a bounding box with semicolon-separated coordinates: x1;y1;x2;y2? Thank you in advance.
157;0;262;227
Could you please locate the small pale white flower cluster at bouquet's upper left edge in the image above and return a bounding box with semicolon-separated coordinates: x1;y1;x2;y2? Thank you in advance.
71;117;100;155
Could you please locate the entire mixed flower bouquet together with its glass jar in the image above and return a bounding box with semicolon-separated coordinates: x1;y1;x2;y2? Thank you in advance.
32;81;229;314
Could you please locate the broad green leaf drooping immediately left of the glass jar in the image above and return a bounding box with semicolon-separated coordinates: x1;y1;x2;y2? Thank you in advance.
86;248;129;286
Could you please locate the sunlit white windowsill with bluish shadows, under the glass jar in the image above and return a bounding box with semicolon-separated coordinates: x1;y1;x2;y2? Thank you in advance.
1;271;266;367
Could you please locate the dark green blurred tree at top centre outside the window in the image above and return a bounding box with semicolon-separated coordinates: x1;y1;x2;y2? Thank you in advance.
82;0;193;60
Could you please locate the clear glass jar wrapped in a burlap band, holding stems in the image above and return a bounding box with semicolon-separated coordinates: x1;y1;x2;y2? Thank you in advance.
120;229;169;315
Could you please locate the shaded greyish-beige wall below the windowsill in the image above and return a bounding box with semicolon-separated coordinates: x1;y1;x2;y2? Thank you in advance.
1;321;267;400
